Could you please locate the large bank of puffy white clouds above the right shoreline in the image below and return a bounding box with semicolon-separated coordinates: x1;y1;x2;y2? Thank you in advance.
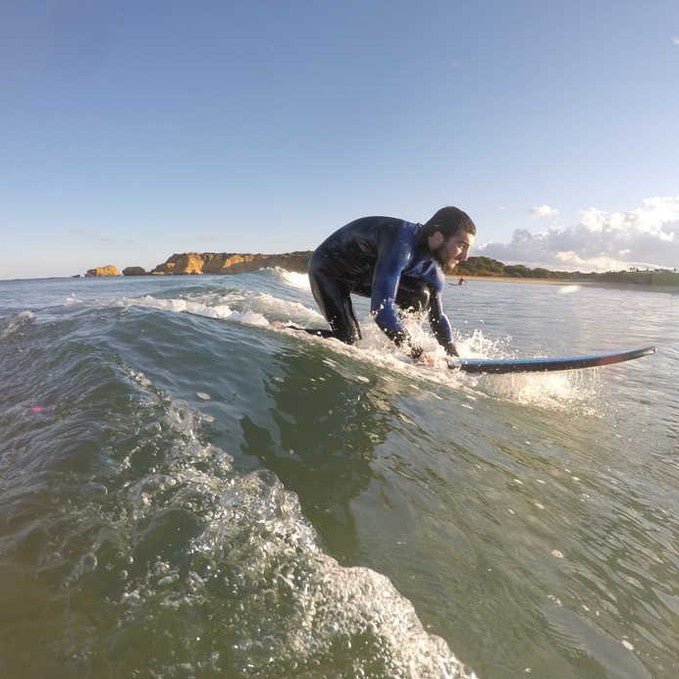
479;195;679;271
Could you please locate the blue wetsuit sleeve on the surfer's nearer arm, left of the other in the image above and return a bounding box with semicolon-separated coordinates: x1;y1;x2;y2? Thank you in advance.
370;231;422;358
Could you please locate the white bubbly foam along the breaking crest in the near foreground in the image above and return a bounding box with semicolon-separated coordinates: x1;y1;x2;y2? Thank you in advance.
109;373;474;679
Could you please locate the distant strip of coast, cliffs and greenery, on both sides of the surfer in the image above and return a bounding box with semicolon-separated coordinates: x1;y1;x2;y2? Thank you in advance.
81;250;679;292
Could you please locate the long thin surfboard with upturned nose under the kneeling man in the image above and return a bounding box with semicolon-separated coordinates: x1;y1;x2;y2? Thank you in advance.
285;325;656;375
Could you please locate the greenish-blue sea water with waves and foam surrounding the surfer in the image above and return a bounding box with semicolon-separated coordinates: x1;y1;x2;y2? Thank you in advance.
0;270;679;678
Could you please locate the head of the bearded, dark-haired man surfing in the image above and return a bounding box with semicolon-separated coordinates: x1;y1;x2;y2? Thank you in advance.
422;206;476;270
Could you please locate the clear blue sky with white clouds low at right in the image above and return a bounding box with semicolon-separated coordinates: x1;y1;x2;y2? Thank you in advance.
0;0;679;279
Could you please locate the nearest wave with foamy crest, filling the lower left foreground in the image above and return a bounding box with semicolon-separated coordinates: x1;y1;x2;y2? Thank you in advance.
0;300;473;678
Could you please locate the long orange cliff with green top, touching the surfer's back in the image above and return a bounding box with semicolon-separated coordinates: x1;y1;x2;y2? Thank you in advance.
151;250;311;276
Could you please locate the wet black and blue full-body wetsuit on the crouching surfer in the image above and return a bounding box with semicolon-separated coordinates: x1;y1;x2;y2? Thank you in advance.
309;217;456;357
